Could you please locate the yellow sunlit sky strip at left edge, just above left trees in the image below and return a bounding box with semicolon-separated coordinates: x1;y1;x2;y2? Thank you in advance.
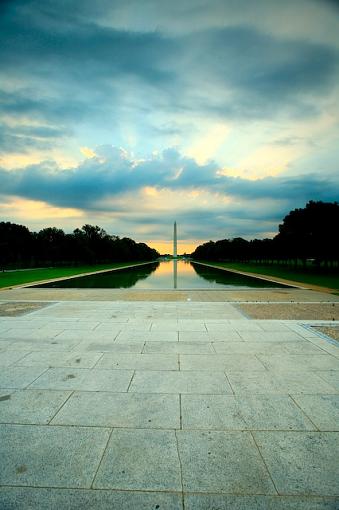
0;197;83;223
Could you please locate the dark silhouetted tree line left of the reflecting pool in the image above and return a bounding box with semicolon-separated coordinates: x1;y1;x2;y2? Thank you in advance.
0;222;159;268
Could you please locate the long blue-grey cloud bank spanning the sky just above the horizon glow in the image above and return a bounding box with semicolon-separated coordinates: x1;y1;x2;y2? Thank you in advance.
0;146;339;210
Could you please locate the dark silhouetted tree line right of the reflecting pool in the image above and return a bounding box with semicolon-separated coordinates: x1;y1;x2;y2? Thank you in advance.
192;201;339;270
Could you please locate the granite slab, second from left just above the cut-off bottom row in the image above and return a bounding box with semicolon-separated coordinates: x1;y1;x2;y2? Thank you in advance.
93;429;182;491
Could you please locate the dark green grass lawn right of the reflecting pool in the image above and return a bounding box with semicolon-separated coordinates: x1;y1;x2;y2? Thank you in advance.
202;262;339;292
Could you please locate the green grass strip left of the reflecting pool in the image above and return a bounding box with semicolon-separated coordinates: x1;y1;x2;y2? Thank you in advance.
0;262;151;288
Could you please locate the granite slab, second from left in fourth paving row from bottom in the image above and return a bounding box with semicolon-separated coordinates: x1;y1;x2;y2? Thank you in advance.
27;367;133;392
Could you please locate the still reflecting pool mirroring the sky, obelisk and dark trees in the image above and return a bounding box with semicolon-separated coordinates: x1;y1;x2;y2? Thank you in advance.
36;260;290;289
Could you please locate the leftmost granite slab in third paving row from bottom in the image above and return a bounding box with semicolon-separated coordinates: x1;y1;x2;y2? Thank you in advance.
0;390;71;425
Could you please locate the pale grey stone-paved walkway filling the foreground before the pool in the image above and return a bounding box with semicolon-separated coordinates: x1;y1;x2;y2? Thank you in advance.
0;296;339;510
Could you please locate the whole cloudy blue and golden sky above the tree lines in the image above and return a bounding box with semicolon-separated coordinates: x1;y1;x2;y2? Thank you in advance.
0;0;339;253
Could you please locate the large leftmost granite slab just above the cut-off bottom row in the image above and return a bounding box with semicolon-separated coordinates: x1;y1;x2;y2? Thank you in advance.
0;425;110;488
